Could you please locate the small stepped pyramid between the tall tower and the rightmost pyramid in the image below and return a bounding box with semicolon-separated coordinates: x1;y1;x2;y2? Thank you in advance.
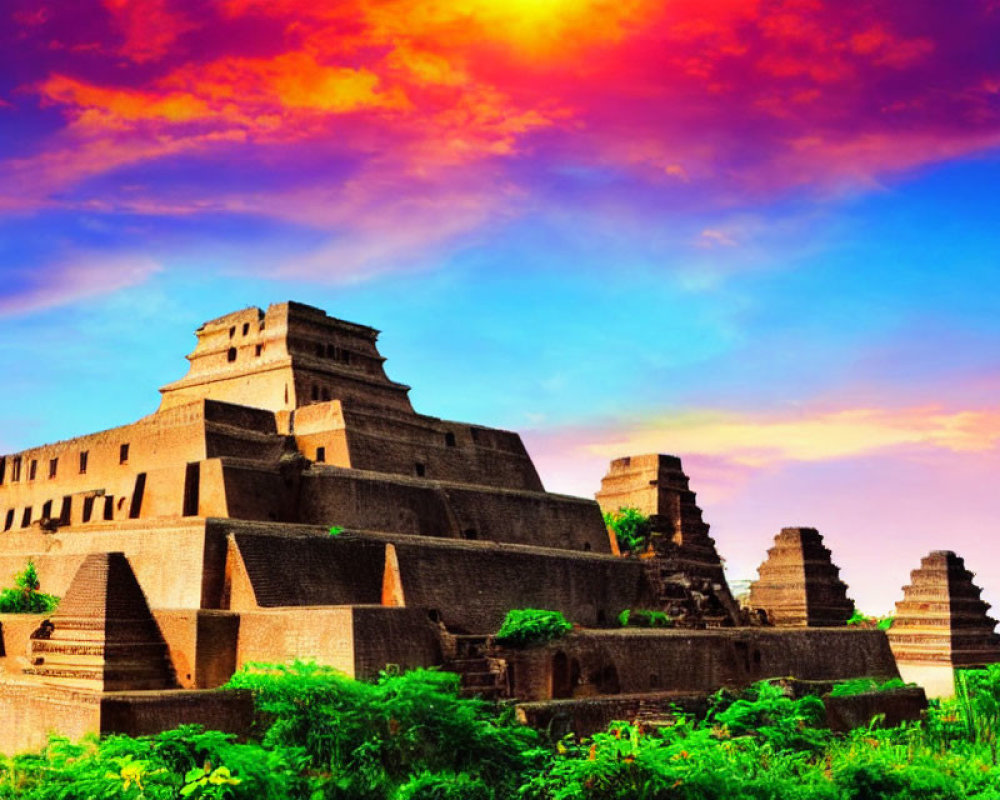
749;528;854;627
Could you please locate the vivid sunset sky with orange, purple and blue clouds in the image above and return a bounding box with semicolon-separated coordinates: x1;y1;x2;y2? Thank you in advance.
0;0;1000;612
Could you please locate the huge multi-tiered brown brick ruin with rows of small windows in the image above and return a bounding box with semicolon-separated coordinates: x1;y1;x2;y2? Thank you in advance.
0;303;919;751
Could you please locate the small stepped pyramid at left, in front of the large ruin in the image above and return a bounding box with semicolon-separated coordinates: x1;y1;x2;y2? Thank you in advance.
25;553;176;691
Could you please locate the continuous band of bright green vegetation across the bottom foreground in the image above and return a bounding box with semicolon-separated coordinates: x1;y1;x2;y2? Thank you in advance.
7;663;1000;800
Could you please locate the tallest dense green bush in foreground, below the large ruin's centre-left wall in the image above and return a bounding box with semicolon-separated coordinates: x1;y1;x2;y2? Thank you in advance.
229;662;537;800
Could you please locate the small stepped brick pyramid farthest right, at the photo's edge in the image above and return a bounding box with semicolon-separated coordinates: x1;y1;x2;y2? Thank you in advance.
889;550;1000;667
